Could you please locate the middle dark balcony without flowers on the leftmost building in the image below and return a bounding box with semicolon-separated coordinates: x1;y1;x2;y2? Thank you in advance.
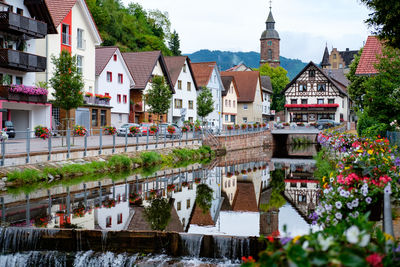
0;48;46;72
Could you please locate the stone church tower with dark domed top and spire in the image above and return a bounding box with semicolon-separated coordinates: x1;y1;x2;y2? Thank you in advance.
260;1;281;68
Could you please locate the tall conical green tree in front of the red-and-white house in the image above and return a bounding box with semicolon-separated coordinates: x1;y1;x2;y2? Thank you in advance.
50;50;84;126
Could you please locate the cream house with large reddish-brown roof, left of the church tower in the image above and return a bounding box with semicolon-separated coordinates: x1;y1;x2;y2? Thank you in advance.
221;71;263;124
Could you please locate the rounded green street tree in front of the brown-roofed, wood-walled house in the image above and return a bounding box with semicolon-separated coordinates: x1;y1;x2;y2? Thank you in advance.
144;76;172;123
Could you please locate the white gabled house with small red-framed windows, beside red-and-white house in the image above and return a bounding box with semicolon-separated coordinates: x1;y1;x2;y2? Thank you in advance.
95;47;135;128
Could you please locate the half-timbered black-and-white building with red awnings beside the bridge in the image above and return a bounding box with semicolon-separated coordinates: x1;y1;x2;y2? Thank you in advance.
284;62;351;123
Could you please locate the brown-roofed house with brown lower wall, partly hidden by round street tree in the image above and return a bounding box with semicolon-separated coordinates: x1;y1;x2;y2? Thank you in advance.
122;51;175;123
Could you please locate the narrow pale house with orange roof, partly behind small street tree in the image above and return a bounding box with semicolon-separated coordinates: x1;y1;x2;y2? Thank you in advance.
192;62;224;129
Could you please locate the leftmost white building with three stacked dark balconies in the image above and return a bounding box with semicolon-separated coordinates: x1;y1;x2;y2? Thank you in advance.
0;0;57;137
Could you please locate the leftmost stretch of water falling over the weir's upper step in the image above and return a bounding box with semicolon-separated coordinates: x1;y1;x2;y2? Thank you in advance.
0;227;58;253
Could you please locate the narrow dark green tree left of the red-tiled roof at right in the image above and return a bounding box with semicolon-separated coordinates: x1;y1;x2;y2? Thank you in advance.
346;49;368;110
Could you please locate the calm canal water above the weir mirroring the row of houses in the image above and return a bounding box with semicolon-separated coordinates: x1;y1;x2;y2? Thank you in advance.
0;149;319;236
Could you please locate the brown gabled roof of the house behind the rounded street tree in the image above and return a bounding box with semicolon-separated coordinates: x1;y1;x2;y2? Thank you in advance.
122;51;175;93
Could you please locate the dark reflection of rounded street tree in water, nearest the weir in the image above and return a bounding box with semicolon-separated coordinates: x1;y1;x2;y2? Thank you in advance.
144;198;172;231
